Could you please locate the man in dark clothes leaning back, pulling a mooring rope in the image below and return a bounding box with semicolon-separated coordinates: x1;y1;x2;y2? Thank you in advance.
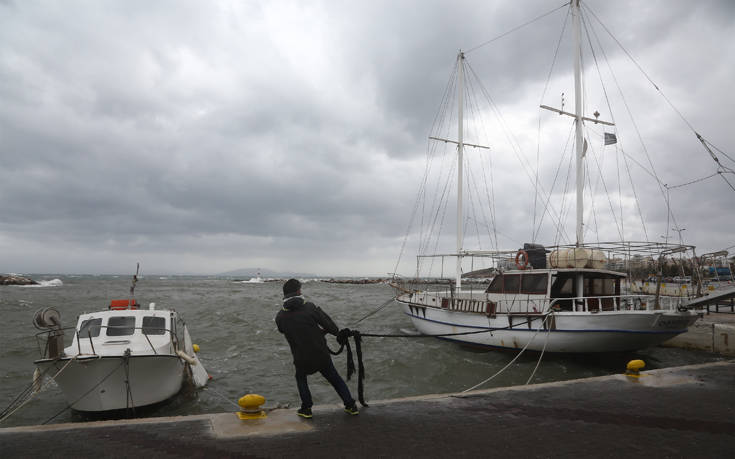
276;279;359;419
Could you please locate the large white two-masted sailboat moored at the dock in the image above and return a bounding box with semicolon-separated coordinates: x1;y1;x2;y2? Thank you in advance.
393;0;712;353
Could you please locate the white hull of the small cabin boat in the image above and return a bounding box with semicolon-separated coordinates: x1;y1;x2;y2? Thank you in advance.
35;355;185;412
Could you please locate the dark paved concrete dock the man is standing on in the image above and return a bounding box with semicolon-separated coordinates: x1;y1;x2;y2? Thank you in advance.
0;361;735;458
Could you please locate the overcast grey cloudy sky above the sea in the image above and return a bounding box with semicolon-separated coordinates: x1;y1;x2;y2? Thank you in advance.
0;0;735;275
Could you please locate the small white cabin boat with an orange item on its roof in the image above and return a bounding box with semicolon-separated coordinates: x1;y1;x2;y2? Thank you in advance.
34;284;209;412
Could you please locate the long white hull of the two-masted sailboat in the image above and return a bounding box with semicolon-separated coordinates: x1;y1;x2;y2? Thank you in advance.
402;302;698;353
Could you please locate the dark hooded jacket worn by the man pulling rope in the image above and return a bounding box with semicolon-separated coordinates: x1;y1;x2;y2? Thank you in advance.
276;296;339;374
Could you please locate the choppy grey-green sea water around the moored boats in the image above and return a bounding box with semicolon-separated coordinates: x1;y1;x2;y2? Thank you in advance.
0;275;719;427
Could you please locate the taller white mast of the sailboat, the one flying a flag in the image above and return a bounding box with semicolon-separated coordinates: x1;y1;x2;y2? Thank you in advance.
572;0;584;247
